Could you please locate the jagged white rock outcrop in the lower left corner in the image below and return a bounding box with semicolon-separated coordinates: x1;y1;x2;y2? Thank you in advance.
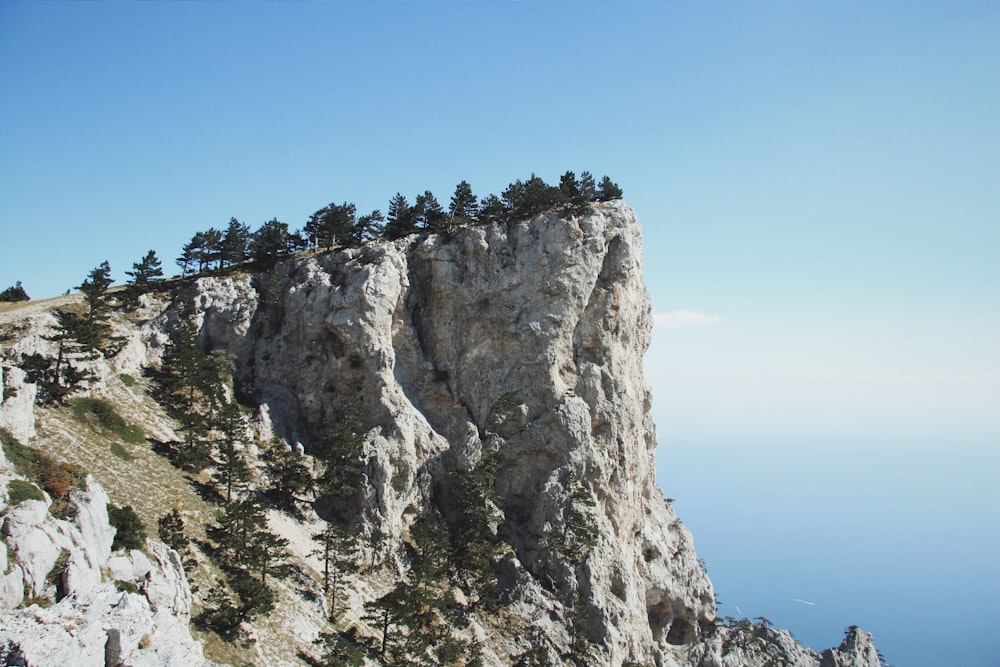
0;440;211;667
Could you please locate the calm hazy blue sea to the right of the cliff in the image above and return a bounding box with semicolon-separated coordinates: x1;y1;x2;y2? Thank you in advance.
657;438;1000;667
